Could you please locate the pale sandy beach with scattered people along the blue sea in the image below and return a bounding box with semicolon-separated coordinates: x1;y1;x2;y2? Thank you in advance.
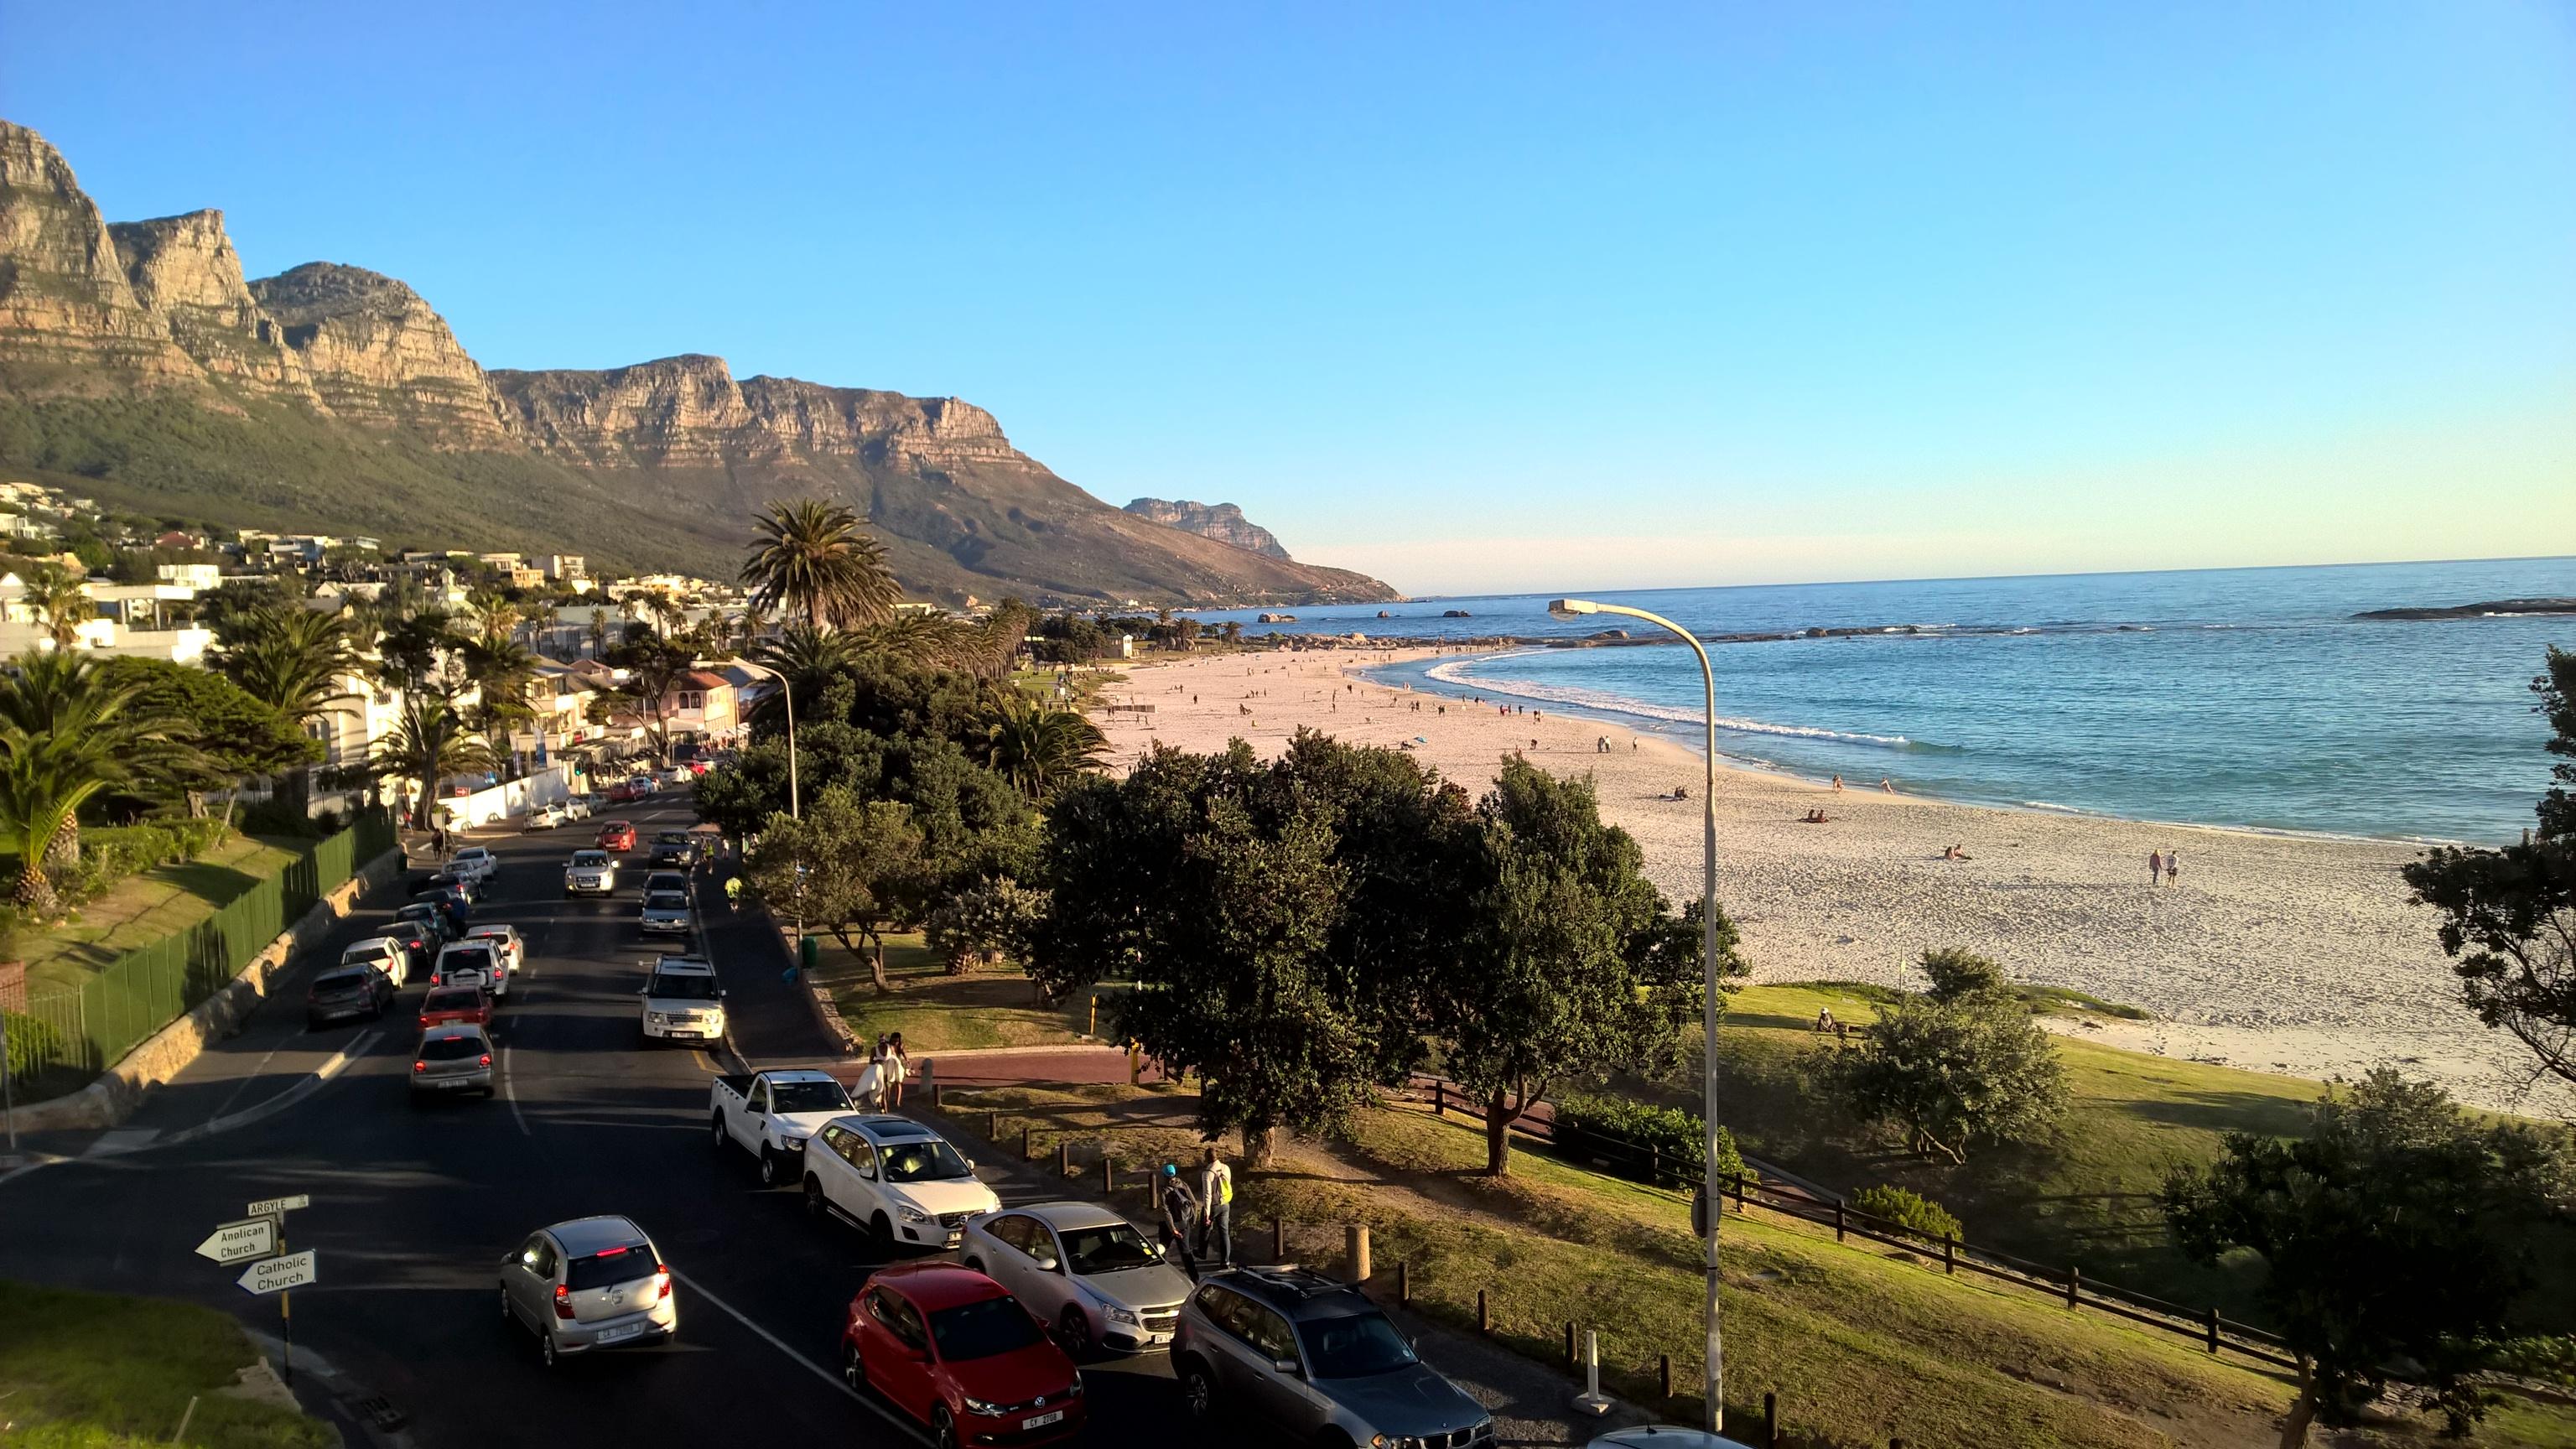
1095;650;2576;1116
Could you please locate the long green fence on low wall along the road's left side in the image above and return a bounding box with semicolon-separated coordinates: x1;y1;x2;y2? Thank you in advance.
8;809;394;1096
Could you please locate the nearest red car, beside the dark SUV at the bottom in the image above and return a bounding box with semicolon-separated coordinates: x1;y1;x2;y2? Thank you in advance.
839;1261;1084;1444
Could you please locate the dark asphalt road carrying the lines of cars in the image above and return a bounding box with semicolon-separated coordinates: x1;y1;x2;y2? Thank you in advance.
0;802;1187;1449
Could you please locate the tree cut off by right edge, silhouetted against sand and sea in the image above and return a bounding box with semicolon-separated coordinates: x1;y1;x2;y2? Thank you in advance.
2406;650;2576;1083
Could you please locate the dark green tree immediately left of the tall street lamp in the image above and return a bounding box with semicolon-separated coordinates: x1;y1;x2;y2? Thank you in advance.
1432;758;1744;1176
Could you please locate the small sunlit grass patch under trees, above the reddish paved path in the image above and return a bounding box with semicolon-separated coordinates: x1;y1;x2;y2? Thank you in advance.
814;933;1089;1055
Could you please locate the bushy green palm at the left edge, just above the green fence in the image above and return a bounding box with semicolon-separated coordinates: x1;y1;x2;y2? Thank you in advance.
0;650;165;916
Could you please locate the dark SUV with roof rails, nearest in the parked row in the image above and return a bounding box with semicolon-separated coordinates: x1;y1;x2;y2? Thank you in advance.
1172;1269;1494;1449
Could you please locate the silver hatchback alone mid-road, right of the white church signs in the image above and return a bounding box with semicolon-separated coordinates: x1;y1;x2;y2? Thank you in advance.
500;1217;680;1369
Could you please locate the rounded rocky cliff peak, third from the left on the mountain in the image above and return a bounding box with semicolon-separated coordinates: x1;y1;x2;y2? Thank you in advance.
250;261;507;449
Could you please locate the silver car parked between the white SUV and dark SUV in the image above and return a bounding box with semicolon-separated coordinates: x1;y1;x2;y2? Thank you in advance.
958;1202;1190;1351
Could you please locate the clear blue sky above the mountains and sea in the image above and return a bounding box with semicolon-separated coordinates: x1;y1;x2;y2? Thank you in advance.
0;0;2576;593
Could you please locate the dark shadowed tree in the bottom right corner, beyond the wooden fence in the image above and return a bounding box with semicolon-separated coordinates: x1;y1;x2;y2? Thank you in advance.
2163;1067;2568;1449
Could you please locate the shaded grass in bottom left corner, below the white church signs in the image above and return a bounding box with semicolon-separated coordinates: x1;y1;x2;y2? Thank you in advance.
0;1281;340;1449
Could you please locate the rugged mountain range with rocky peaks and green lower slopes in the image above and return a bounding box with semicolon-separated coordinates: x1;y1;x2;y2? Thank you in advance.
0;122;1394;603
